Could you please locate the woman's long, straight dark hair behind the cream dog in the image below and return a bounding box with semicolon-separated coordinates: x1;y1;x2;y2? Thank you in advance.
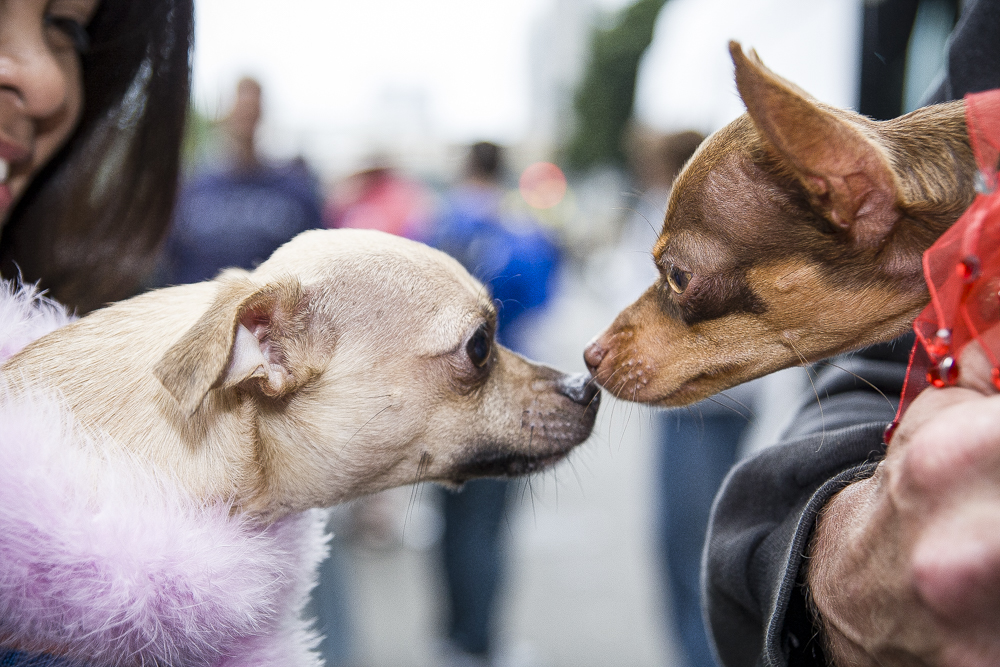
0;0;194;312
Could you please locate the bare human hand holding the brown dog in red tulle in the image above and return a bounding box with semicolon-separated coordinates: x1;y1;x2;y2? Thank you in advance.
806;343;1000;667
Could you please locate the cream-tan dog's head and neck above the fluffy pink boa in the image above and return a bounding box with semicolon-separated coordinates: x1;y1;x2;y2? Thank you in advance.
2;230;597;521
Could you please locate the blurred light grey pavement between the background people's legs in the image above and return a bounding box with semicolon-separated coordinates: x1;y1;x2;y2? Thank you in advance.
328;266;801;667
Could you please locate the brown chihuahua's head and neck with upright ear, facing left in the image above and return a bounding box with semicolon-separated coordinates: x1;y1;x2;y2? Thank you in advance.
584;42;976;406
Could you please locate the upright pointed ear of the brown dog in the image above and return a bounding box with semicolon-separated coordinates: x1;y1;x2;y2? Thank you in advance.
729;42;900;247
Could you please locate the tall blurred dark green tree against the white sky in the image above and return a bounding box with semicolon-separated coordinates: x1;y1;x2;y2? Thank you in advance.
565;0;666;169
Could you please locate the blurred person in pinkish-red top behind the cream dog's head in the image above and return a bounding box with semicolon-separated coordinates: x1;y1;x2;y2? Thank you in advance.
323;157;433;241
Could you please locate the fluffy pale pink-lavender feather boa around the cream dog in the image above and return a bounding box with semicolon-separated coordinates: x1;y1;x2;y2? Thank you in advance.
0;281;327;667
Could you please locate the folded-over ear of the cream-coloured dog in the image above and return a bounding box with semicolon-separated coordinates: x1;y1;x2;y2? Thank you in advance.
153;278;305;416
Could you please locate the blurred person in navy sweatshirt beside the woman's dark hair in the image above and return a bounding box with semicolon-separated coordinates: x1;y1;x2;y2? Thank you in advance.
161;77;320;284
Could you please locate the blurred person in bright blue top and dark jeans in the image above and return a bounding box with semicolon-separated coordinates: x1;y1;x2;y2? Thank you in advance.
432;142;560;667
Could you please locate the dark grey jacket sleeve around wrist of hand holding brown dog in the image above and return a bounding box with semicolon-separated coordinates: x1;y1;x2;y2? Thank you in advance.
702;336;912;667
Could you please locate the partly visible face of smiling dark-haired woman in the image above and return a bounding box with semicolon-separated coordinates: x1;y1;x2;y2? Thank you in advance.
0;0;100;226
